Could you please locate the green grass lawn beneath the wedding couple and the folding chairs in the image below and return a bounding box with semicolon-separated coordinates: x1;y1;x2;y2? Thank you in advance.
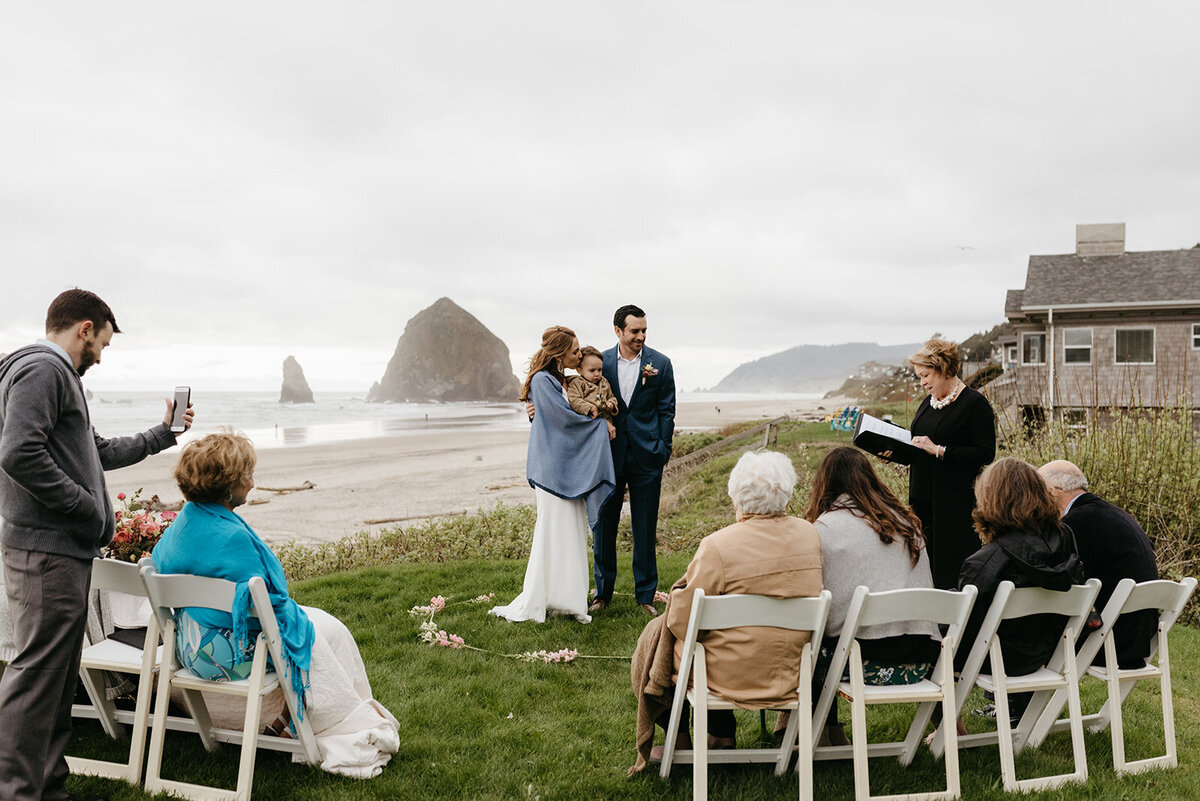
63;419;1200;801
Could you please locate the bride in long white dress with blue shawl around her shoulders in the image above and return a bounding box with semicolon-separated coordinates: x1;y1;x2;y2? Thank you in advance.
491;325;613;624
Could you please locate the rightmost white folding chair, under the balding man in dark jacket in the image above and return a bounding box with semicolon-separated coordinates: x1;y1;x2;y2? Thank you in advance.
1030;577;1196;775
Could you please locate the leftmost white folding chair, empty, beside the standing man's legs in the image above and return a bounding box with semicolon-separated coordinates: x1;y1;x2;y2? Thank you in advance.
67;559;162;784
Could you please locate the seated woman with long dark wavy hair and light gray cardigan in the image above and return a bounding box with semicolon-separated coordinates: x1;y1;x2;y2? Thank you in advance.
804;446;941;745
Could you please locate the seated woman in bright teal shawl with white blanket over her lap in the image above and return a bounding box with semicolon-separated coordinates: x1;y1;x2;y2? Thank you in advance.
152;433;400;778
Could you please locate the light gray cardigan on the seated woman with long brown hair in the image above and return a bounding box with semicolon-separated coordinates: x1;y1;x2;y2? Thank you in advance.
814;503;942;640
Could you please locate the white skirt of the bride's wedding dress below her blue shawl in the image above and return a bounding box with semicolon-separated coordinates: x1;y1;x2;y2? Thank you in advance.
491;488;592;624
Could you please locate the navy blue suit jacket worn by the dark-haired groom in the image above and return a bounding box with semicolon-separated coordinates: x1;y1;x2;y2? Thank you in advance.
604;345;674;475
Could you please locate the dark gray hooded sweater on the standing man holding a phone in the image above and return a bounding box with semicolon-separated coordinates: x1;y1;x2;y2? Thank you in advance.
0;345;175;559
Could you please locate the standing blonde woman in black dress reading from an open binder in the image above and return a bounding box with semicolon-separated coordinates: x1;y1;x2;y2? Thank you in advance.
908;338;996;590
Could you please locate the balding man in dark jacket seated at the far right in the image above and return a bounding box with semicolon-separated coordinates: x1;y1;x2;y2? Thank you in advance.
1038;459;1158;669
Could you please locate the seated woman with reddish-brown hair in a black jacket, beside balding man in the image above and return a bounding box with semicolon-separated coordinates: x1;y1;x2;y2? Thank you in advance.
955;457;1084;724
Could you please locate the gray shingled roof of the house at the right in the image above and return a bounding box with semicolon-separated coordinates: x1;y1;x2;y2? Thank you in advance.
1004;246;1200;317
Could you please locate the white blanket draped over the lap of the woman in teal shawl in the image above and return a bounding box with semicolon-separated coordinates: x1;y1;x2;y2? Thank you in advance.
304;607;400;778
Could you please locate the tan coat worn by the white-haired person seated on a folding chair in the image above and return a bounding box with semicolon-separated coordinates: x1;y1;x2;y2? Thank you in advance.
666;516;822;709
